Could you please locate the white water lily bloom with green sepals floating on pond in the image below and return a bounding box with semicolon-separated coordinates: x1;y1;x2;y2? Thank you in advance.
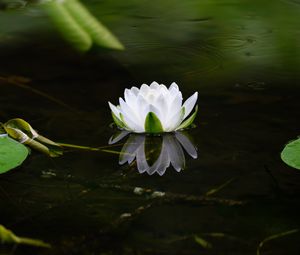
108;82;198;133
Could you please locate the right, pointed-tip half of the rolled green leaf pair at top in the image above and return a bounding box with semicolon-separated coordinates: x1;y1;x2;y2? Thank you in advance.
63;0;124;50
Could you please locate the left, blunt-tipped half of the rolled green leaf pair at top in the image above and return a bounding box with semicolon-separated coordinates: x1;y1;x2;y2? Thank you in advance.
43;0;92;51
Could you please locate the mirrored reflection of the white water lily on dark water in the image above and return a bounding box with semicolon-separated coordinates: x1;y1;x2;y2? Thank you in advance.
109;131;198;175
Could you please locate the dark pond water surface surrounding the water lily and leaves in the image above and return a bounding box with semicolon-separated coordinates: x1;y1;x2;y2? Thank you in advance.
0;0;300;255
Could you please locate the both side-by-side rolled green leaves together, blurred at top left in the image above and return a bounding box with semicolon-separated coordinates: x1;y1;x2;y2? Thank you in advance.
42;0;124;51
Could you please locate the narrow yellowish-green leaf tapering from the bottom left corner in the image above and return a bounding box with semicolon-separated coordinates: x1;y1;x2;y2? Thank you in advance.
0;225;51;248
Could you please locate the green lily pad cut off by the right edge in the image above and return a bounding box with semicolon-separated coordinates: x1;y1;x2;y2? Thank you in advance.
281;138;300;170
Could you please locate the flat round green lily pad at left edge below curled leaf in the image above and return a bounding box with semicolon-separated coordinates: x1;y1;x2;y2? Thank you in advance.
0;135;29;174
